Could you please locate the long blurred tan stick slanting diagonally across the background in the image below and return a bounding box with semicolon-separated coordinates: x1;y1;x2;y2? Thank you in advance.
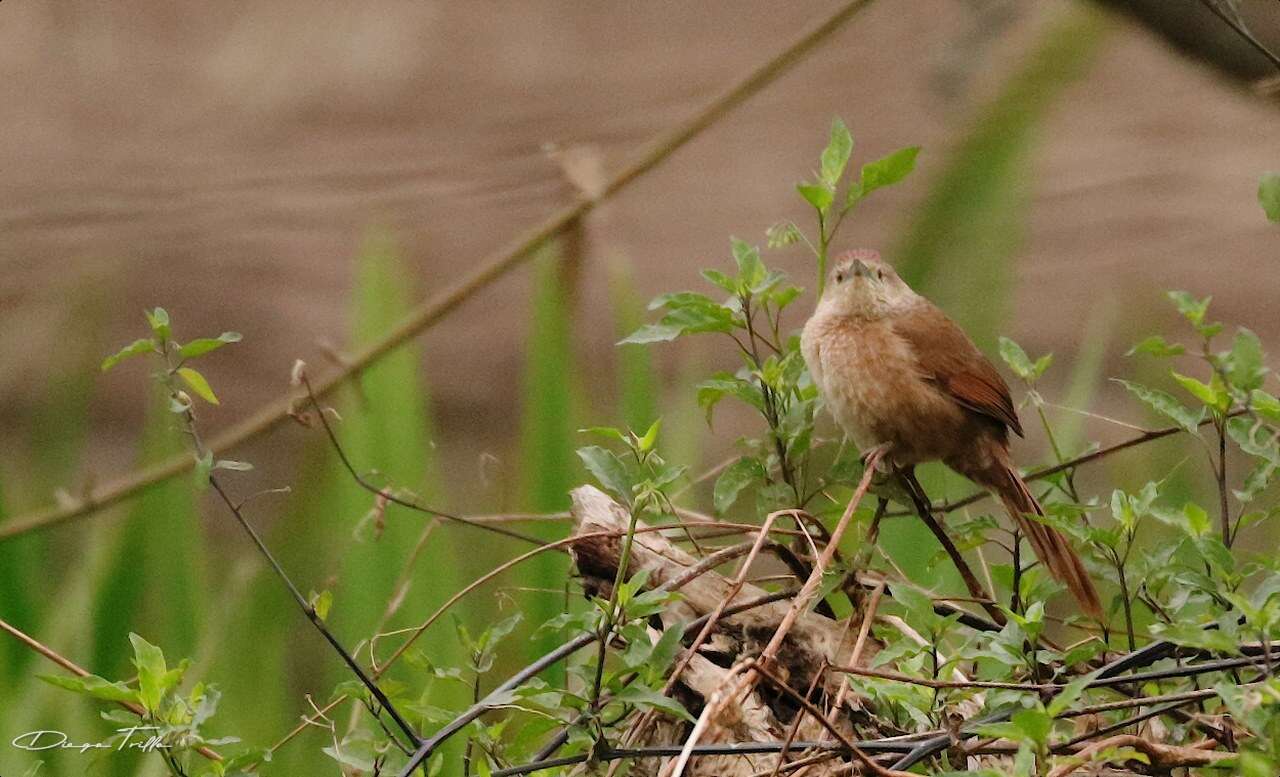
0;0;870;540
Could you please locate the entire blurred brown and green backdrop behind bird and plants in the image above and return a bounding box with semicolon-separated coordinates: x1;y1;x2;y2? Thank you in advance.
0;0;1280;777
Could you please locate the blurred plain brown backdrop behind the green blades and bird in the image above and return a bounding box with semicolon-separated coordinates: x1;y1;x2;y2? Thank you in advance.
0;0;1280;512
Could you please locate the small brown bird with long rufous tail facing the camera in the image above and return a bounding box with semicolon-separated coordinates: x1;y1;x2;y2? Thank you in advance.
800;248;1102;618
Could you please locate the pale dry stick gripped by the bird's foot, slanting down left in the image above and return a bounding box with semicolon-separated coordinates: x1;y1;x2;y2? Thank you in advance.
671;448;884;777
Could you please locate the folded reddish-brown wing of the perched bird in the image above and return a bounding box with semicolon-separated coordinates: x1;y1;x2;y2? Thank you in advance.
893;303;1023;437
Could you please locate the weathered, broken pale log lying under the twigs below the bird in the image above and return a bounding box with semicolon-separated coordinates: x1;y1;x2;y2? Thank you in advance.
571;485;879;777
